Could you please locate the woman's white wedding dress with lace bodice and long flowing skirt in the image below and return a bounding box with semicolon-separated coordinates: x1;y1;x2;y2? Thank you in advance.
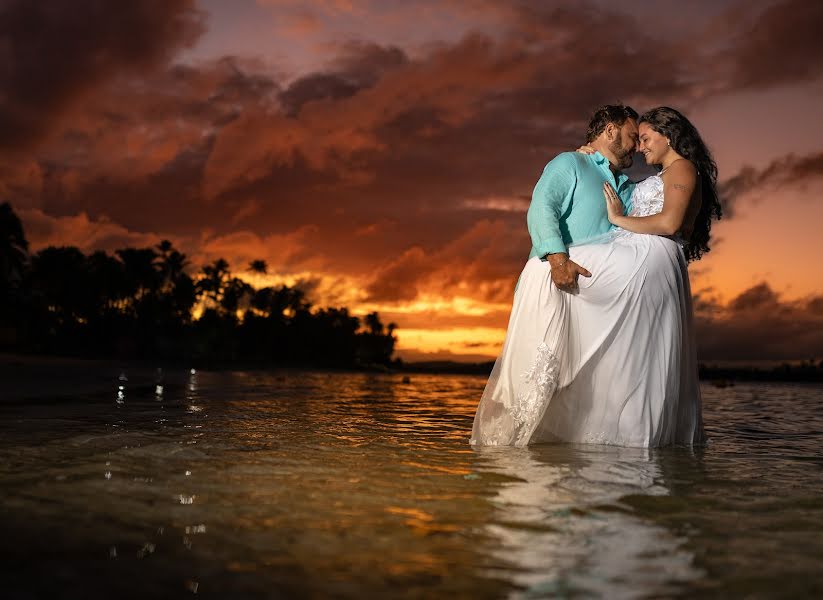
471;175;704;447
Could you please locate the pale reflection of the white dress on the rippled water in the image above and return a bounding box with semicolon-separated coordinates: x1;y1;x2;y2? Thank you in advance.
475;445;702;598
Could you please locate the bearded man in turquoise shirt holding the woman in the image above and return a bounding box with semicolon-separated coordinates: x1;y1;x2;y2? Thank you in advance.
526;104;638;292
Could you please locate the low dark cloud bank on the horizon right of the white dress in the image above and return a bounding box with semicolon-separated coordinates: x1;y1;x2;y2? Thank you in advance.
695;283;823;361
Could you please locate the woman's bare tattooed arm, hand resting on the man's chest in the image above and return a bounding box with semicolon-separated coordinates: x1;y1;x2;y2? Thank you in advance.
603;160;697;235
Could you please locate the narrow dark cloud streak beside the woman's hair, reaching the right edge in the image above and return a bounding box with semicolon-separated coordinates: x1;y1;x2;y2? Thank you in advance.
719;152;823;217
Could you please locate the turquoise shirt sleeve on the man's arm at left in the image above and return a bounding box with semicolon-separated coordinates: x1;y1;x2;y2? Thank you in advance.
526;153;577;258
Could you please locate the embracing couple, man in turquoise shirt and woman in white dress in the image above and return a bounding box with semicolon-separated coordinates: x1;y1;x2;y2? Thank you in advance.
471;105;720;447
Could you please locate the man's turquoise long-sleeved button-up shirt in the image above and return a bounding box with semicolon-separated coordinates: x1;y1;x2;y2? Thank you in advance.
526;152;635;258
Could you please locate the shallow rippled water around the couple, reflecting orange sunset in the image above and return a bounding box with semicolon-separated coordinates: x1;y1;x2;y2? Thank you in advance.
0;371;823;598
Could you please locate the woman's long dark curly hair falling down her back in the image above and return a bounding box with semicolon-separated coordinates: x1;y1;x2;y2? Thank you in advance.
638;106;723;260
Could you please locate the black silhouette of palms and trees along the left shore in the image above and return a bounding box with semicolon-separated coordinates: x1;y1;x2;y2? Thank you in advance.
0;203;396;368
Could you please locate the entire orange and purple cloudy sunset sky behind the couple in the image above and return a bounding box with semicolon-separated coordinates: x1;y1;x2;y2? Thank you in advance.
0;0;823;361
